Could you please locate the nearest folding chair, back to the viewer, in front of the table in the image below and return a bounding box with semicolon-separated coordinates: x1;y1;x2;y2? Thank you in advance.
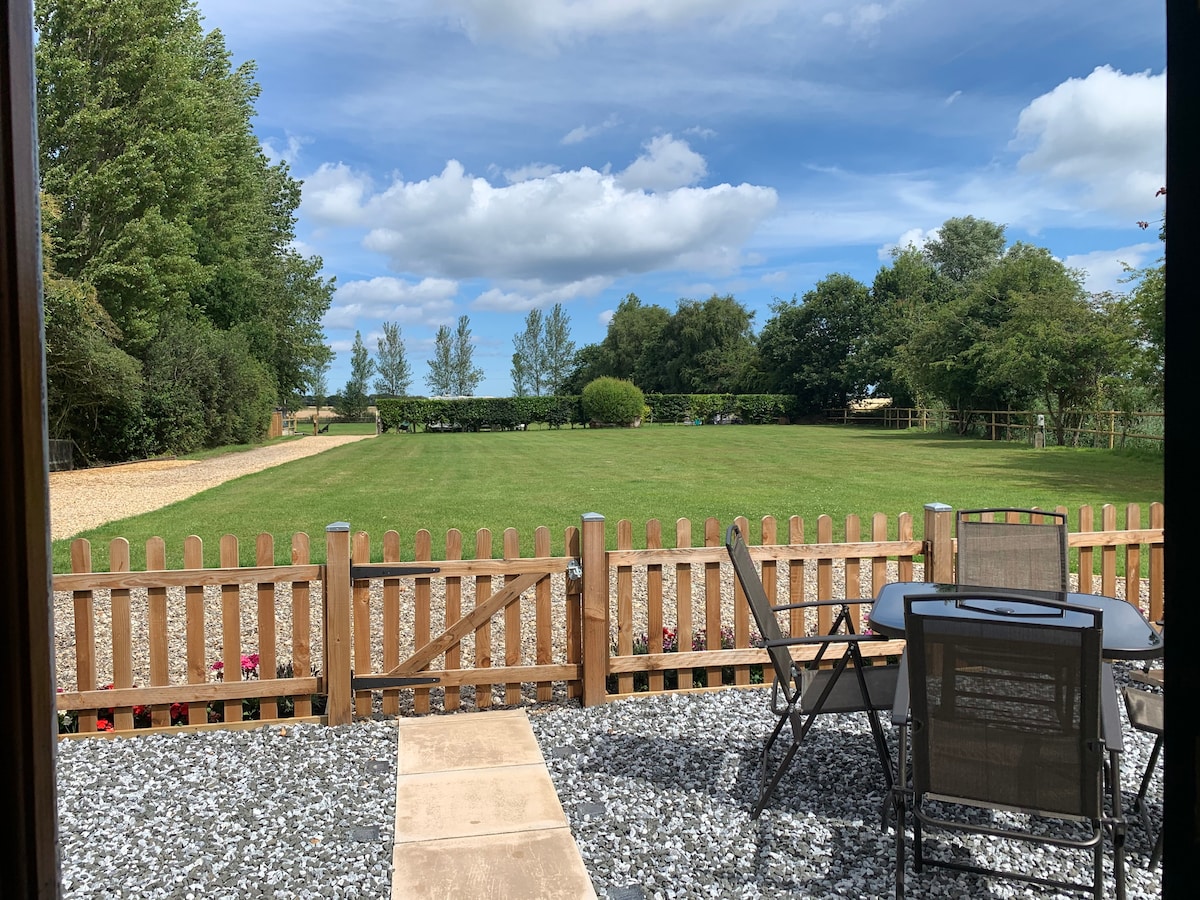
893;590;1126;899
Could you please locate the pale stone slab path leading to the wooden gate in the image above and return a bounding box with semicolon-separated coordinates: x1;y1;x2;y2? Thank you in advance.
391;709;596;900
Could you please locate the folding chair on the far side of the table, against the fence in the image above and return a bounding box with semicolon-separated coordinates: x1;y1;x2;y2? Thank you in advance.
955;508;1070;590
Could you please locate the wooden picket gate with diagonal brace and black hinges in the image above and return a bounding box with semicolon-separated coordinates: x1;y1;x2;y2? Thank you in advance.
340;528;582;715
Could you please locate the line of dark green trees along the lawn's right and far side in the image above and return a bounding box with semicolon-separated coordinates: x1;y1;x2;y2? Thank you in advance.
564;216;1165;443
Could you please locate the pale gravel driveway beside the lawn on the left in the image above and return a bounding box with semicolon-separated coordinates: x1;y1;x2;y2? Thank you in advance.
50;434;374;540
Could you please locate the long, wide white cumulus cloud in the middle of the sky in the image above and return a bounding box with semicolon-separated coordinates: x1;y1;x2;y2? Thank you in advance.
305;153;778;293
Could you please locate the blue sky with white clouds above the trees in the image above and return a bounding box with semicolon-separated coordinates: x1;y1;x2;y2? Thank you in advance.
189;0;1166;396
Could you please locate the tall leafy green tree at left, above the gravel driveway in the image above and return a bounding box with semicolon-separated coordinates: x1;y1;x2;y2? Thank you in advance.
35;0;332;454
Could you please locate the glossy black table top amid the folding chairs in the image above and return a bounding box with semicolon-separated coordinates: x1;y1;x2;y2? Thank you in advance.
869;581;1163;659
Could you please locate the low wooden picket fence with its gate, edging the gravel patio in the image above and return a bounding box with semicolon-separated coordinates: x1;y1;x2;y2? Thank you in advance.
54;503;1164;734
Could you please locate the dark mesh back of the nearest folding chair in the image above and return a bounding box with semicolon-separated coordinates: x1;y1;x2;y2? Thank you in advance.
905;595;1103;820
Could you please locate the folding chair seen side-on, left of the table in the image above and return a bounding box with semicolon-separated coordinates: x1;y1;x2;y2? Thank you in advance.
725;524;899;818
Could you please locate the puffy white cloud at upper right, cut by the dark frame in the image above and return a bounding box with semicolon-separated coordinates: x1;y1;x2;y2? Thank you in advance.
1014;66;1166;216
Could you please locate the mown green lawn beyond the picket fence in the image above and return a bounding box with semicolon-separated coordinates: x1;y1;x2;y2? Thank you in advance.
54;426;1163;571
